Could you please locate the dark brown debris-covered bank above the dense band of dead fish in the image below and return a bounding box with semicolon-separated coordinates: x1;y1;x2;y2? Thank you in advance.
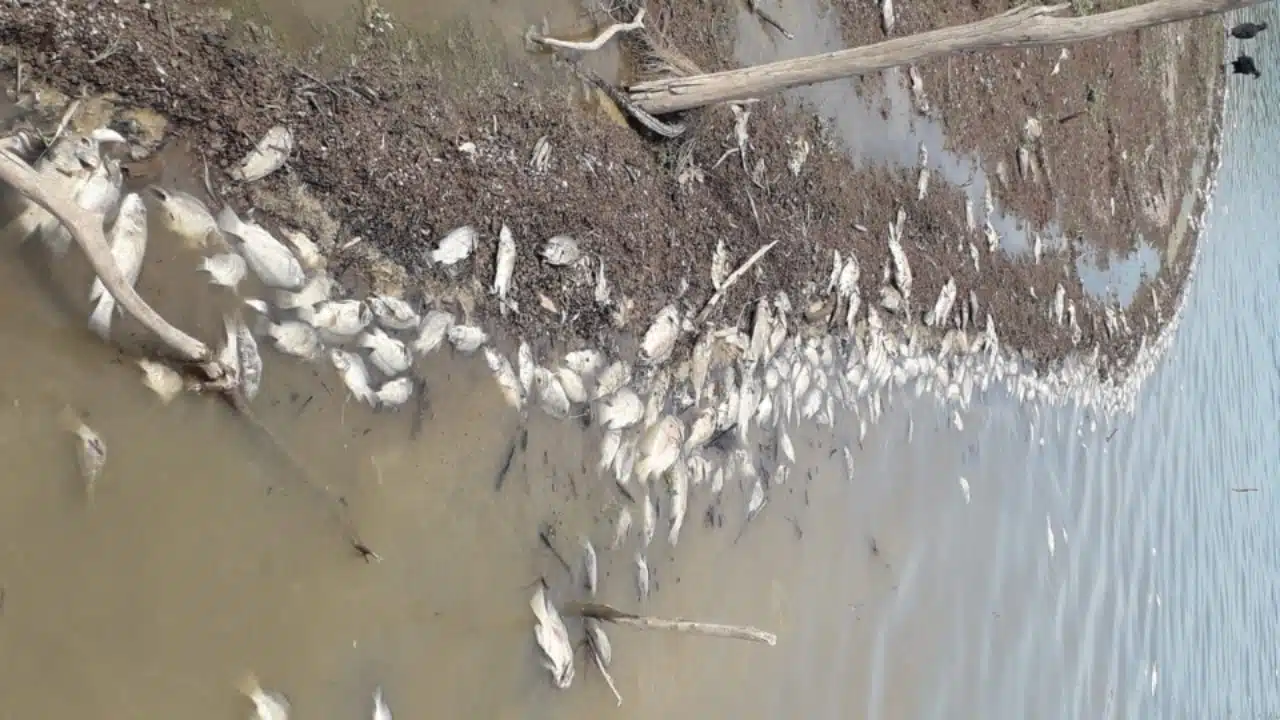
0;1;1222;381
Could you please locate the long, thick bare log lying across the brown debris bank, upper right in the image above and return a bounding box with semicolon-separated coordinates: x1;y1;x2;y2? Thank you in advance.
627;0;1270;115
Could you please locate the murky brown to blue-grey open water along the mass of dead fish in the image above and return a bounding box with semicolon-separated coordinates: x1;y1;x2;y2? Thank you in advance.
0;4;1280;719
